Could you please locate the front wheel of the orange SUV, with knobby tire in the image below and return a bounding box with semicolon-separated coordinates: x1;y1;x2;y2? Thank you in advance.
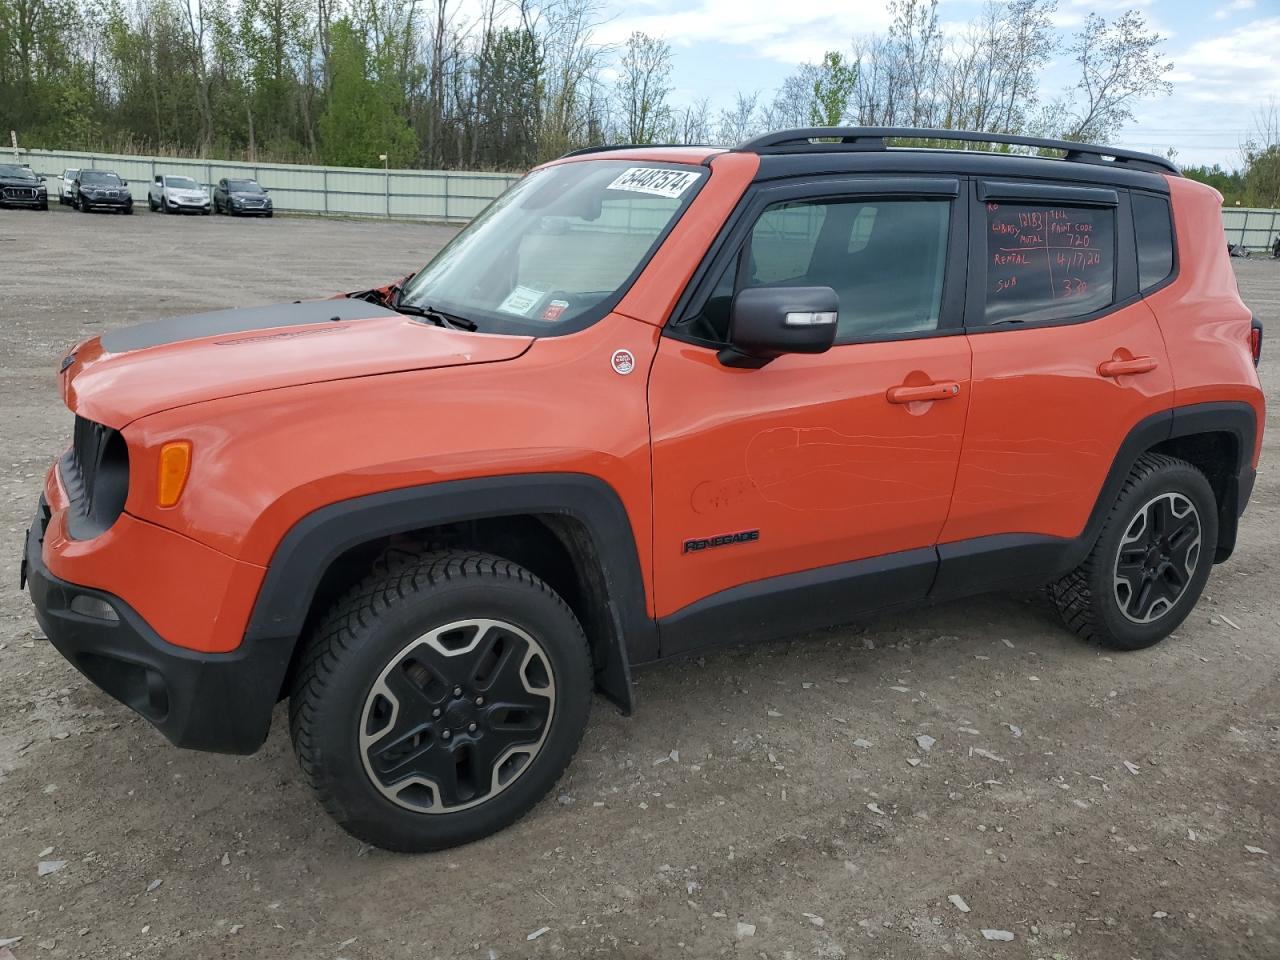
289;550;593;851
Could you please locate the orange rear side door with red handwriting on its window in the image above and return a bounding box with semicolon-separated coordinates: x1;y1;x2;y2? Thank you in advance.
934;180;1172;595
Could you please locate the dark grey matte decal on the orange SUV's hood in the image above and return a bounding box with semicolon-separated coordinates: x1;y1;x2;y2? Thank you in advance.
102;298;397;353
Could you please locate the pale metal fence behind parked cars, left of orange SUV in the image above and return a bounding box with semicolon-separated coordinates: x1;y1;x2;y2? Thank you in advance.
8;150;520;223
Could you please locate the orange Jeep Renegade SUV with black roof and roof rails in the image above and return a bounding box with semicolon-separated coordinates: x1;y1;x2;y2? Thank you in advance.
23;128;1263;850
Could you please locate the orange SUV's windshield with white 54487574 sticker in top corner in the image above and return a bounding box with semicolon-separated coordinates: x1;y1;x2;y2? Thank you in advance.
399;160;707;334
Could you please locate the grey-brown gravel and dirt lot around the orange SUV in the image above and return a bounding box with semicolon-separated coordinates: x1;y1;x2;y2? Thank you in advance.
0;209;1280;960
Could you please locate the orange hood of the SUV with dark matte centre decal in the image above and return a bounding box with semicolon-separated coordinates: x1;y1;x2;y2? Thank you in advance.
59;298;532;429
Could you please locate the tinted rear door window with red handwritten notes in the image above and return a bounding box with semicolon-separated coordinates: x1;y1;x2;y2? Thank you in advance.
986;202;1116;324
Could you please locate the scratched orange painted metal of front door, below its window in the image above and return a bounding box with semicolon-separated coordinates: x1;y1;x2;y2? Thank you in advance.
649;337;970;616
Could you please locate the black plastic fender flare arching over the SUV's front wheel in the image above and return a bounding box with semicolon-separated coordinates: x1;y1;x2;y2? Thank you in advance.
244;472;658;713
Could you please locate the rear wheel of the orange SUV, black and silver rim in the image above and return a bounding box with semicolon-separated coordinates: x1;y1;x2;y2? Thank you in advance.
1050;453;1217;650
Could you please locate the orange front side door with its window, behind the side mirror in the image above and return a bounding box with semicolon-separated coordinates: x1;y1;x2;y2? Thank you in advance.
649;178;970;654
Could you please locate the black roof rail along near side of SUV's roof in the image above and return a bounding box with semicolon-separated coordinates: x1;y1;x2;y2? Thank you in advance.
735;127;1181;177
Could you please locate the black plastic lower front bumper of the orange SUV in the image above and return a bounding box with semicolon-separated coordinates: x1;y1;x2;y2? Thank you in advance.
22;497;292;754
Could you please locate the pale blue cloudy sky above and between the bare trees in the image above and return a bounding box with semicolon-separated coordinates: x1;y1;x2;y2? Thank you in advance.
586;0;1280;168
